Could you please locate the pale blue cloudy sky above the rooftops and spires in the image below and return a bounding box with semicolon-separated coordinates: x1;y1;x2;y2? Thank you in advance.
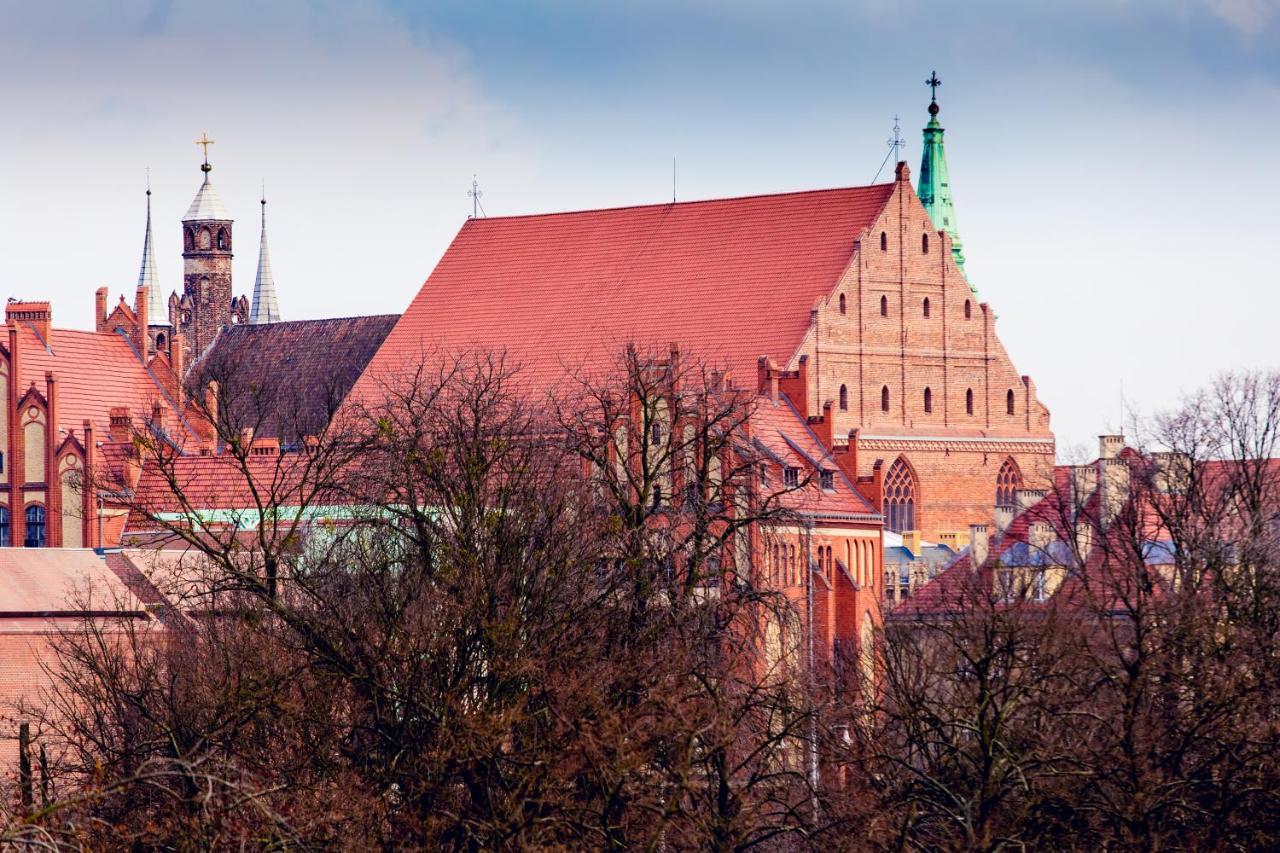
0;0;1280;456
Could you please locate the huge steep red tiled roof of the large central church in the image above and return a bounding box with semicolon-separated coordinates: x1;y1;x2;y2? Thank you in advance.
355;184;895;398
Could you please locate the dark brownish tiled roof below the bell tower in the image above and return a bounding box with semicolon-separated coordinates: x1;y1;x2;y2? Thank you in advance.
187;314;399;443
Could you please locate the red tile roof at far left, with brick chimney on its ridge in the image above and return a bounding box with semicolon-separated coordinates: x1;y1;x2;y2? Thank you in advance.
18;324;183;435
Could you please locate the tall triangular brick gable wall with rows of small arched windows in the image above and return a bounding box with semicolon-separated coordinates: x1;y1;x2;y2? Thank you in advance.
790;168;1053;539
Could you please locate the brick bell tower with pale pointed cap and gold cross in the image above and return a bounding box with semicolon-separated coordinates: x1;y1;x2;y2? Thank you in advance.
173;134;239;359
